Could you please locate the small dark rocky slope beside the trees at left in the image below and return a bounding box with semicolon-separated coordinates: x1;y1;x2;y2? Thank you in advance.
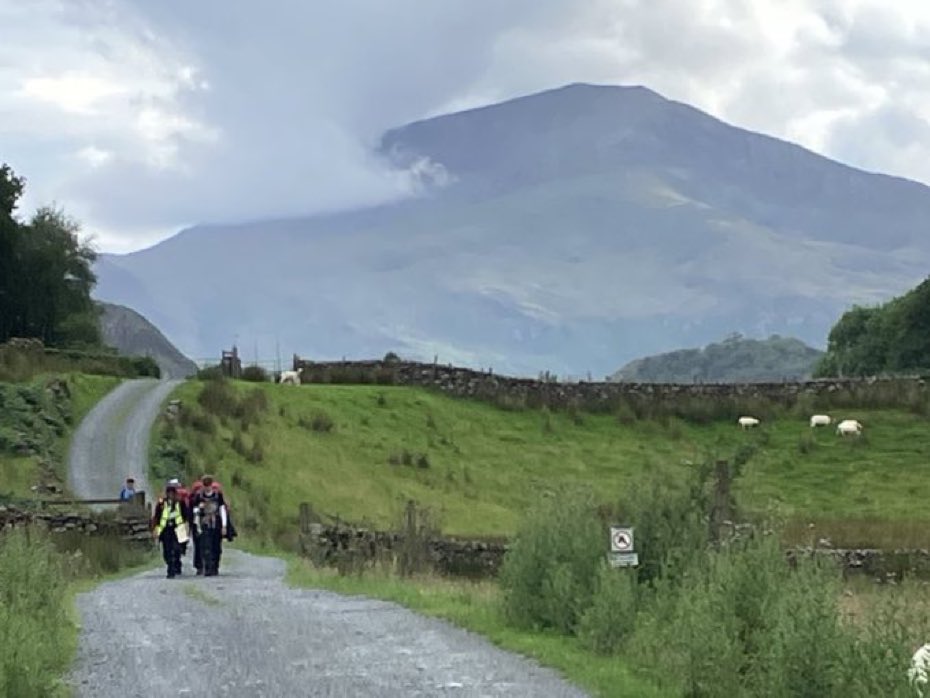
100;303;197;378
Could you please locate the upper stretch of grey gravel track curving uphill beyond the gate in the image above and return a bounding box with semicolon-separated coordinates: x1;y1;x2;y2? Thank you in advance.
68;378;179;499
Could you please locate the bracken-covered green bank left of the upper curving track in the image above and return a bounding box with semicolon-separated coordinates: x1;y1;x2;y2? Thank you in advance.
0;374;119;500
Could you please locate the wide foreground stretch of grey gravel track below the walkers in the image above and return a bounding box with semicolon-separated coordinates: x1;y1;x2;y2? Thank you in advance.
71;549;585;698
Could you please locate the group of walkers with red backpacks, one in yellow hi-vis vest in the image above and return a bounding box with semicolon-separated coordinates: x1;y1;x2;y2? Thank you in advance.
152;475;236;579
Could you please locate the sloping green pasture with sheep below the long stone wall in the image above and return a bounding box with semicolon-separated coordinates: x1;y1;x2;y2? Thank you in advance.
163;382;930;547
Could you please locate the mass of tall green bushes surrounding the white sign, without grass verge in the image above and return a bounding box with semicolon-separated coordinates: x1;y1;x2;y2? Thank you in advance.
490;470;930;698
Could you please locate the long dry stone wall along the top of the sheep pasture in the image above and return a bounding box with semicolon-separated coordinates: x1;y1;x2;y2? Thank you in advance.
294;356;928;411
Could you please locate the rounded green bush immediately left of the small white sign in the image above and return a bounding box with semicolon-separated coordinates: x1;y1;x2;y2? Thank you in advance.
500;493;606;633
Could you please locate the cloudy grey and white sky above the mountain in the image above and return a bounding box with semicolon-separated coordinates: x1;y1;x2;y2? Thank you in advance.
0;0;930;252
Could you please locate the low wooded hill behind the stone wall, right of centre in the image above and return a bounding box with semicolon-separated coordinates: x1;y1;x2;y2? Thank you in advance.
610;334;823;383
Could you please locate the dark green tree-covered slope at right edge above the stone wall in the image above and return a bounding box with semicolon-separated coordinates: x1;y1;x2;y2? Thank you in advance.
816;279;930;376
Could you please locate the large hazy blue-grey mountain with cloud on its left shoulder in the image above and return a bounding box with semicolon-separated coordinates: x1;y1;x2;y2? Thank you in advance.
90;85;930;376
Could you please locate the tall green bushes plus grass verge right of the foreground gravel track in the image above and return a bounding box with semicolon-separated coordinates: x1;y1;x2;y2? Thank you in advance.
289;462;930;698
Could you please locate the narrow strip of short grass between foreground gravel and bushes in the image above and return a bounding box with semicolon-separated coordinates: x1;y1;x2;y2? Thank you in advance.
287;557;662;698
